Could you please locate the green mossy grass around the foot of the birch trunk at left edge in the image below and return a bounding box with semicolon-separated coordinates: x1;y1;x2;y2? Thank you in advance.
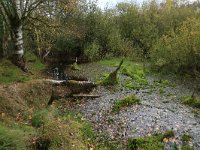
0;52;45;84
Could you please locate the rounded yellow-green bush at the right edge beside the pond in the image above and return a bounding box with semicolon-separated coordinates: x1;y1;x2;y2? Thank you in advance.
151;18;200;72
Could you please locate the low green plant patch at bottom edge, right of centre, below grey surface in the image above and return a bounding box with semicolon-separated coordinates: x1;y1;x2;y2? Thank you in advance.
127;131;174;150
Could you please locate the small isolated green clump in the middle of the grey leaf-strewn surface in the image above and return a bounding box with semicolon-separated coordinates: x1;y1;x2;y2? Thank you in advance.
112;94;140;112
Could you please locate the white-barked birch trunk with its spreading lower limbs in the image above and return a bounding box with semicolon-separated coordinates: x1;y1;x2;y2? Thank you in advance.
0;0;45;71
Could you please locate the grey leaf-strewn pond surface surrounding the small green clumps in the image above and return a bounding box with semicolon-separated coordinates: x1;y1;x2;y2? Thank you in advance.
66;64;200;150
